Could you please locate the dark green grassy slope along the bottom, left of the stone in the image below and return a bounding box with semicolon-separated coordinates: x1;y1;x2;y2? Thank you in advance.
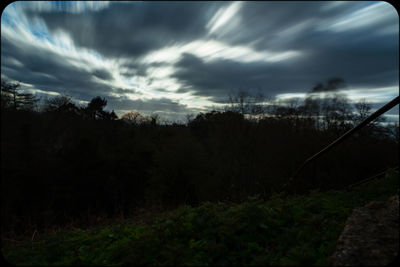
2;171;399;266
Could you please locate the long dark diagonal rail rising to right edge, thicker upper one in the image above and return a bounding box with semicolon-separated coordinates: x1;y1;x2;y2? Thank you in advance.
281;96;400;194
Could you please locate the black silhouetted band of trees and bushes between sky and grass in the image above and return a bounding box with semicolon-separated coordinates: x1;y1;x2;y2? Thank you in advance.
1;79;399;237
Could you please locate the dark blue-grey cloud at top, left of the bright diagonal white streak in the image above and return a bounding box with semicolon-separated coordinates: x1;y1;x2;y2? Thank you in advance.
29;1;224;57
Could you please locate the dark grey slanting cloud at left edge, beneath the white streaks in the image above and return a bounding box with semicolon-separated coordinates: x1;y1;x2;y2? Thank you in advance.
1;28;116;99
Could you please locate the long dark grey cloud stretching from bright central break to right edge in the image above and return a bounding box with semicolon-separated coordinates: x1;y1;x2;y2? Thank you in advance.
175;15;399;99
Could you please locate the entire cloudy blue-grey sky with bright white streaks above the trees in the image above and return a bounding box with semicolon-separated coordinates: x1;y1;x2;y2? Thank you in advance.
1;1;399;121
